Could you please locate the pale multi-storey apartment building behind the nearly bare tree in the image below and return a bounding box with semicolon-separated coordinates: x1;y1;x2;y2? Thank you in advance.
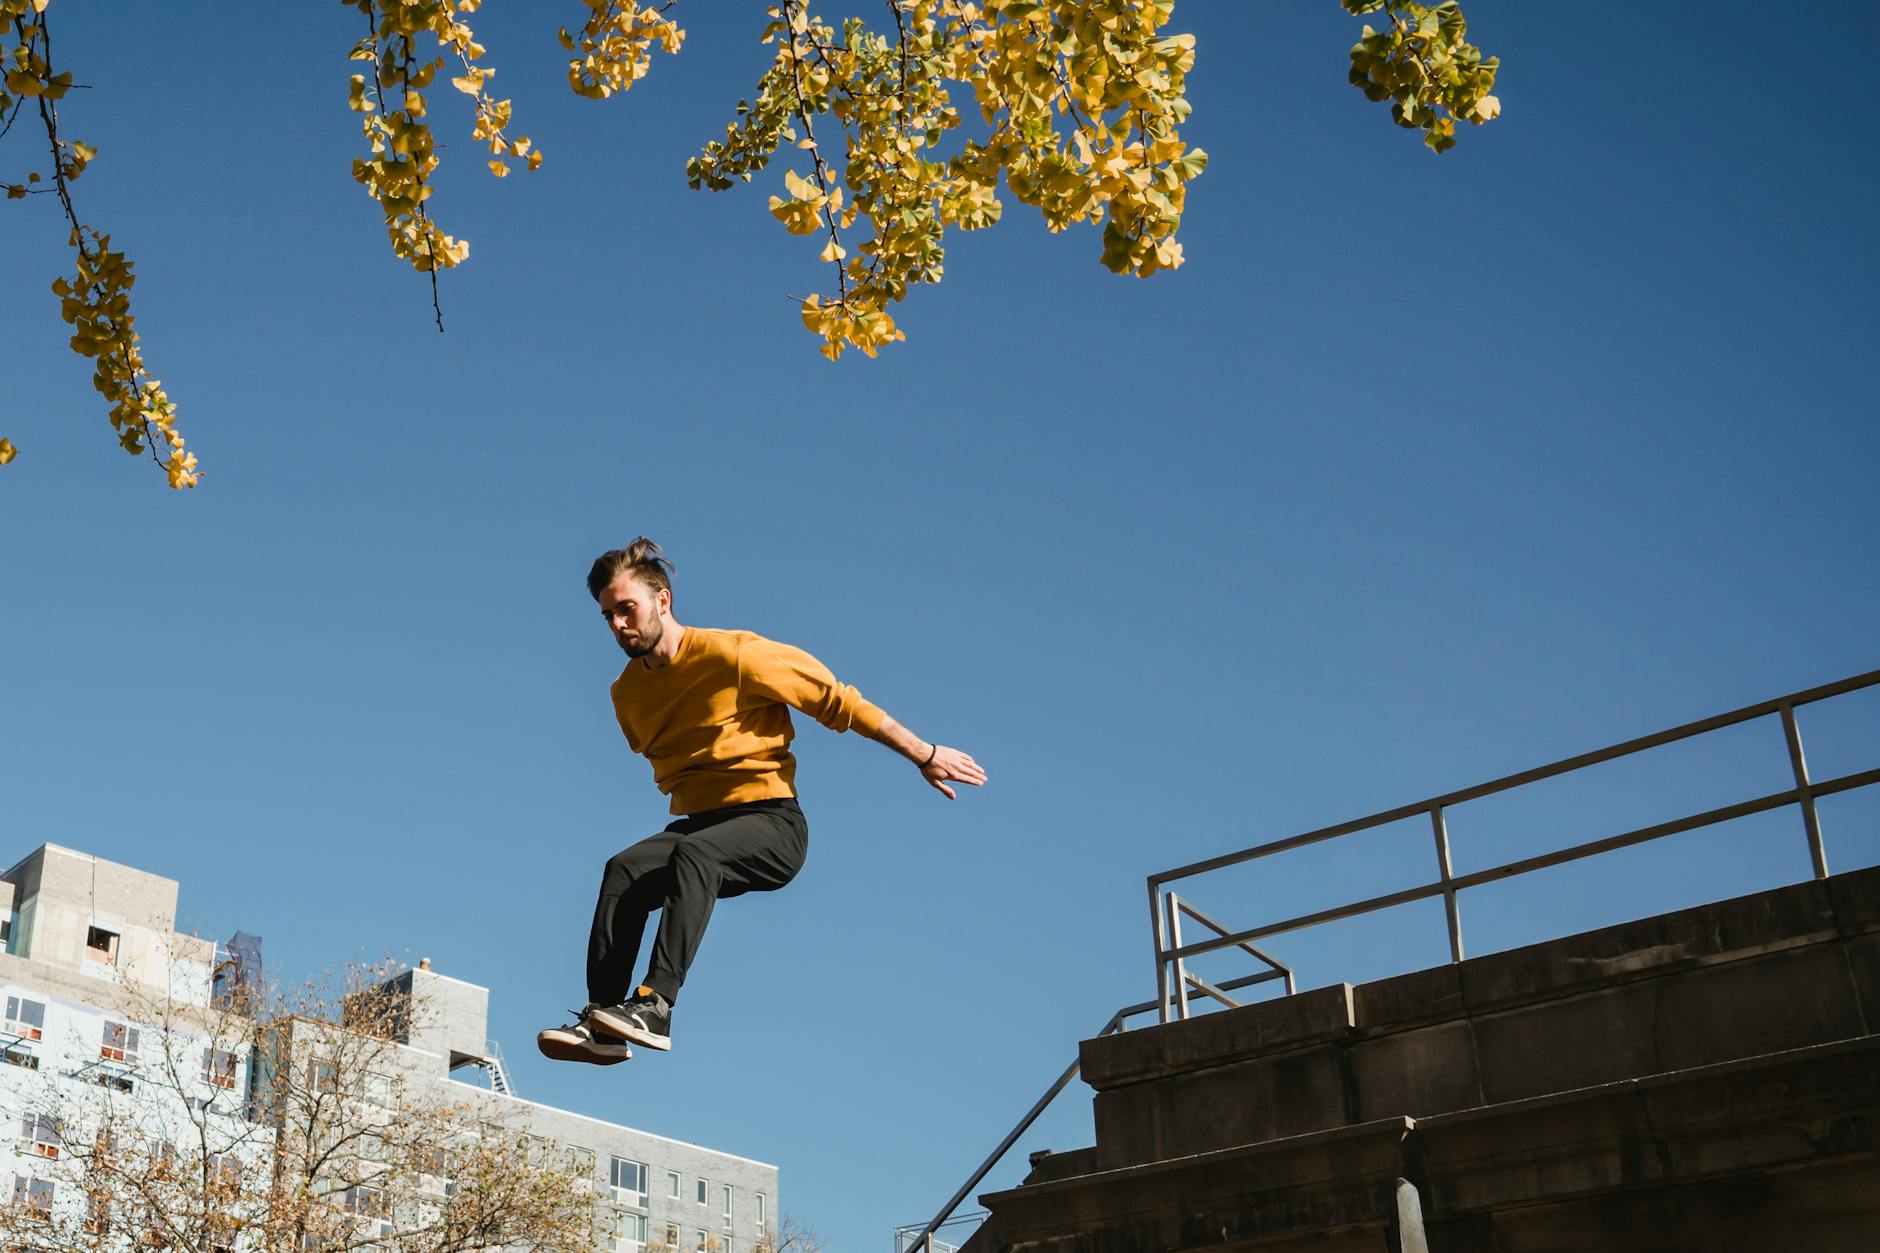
0;845;778;1253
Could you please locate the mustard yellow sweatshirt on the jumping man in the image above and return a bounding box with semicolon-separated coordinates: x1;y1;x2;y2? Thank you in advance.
613;627;887;813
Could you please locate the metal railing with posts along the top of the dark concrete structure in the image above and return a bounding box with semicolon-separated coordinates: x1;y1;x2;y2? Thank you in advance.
1149;670;1880;1022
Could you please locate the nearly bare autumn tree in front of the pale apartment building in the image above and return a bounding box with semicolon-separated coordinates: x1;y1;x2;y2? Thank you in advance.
0;951;596;1253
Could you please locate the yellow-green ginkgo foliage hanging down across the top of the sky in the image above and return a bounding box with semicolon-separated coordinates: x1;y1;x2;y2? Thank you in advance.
0;0;1500;487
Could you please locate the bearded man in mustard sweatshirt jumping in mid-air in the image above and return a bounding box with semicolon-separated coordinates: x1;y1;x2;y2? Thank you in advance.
536;538;985;1065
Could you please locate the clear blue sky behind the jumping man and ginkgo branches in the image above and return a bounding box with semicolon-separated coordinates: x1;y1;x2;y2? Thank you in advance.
0;0;1880;1251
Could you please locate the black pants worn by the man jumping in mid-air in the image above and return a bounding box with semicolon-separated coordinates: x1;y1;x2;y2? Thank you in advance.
588;800;810;1005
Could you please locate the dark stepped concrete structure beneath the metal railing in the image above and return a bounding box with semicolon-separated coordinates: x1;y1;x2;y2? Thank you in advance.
966;869;1880;1253
